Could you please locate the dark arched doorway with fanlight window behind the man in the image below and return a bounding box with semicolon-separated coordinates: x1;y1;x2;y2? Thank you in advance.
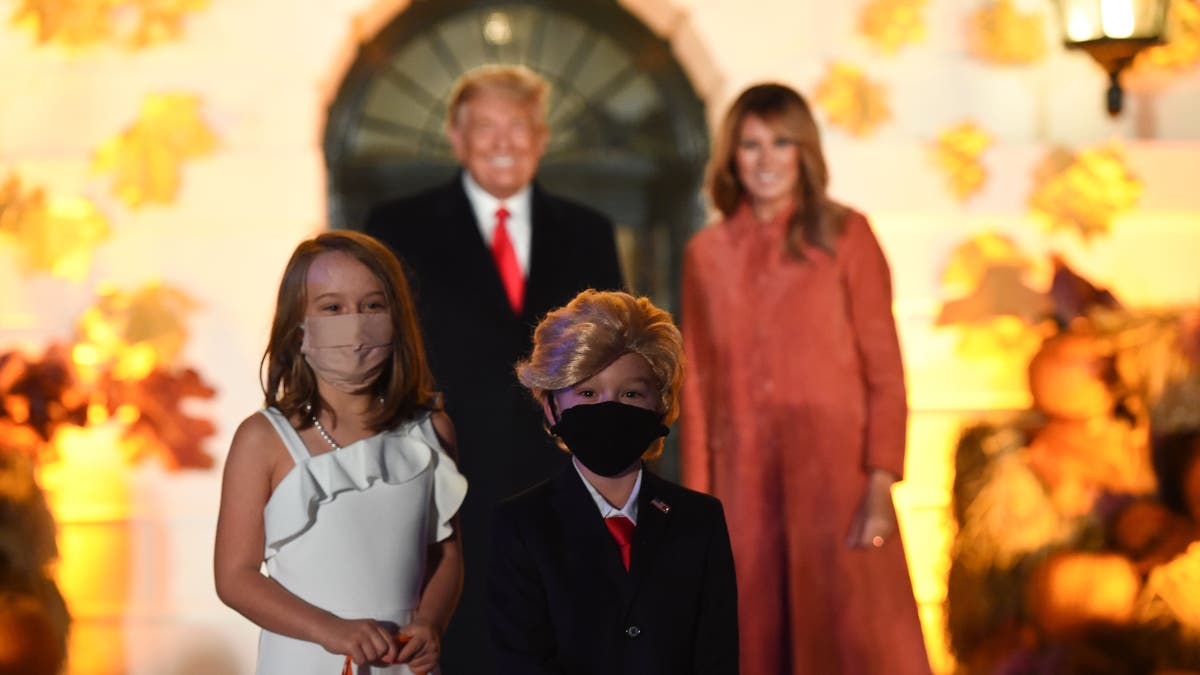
324;0;708;307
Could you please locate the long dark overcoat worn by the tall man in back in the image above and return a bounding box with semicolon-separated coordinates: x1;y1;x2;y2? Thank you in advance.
364;174;623;675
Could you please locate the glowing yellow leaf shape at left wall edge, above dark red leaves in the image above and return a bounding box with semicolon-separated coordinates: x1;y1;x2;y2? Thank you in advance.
0;175;109;281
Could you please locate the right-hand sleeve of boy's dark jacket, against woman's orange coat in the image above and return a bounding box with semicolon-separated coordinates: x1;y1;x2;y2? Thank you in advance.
692;500;738;675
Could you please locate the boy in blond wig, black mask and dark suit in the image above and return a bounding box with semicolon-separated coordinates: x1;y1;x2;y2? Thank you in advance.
487;291;738;675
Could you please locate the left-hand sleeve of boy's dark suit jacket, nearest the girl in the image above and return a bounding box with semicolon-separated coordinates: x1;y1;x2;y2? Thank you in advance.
487;507;565;675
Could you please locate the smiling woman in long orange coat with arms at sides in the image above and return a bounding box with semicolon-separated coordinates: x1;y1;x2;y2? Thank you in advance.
682;84;930;675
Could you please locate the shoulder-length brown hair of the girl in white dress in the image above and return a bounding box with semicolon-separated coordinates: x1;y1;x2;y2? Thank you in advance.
259;231;437;431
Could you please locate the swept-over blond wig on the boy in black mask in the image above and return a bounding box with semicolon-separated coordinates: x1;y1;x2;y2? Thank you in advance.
516;289;684;459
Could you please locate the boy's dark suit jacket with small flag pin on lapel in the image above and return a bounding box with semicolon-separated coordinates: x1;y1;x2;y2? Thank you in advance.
487;466;738;675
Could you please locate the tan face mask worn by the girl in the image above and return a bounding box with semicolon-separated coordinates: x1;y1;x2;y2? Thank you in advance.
300;312;392;394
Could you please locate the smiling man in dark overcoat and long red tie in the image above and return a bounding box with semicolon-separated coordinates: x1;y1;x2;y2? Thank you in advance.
365;66;623;675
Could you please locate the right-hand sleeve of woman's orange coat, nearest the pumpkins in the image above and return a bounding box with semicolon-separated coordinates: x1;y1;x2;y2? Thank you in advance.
839;213;908;478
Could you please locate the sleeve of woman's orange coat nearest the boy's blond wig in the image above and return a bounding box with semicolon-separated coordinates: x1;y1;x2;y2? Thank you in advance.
679;239;713;492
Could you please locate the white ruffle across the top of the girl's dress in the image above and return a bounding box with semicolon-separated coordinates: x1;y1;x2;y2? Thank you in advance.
263;410;467;557
